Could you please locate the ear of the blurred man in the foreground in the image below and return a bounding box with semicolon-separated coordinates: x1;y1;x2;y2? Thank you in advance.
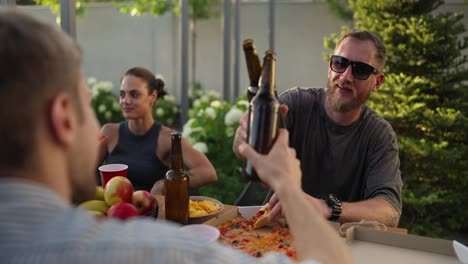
47;93;77;146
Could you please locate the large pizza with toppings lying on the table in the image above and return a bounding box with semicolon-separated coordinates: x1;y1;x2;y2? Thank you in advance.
218;206;296;260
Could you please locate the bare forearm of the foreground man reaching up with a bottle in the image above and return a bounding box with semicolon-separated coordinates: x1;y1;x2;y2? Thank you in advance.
276;184;350;263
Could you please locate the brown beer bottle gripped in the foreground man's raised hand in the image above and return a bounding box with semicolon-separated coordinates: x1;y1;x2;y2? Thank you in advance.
244;50;281;181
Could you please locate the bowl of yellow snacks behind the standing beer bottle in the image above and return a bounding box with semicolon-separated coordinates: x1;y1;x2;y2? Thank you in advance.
189;196;224;224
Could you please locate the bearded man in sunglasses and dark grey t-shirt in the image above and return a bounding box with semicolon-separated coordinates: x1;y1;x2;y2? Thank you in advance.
233;30;403;226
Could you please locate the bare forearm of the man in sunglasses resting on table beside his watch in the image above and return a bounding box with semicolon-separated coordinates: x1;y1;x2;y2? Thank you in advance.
339;198;400;227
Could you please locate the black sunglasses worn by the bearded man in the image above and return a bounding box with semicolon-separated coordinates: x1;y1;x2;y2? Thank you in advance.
330;55;379;80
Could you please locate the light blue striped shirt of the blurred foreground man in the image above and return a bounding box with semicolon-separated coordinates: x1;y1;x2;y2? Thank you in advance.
0;178;316;264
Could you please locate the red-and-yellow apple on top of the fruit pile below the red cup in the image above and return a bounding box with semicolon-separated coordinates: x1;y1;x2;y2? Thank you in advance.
104;176;133;206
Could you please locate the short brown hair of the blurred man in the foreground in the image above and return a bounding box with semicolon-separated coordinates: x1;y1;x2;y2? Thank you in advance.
0;7;83;168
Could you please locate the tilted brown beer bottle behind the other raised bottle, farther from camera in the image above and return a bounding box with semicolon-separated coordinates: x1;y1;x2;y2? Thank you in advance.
242;39;262;102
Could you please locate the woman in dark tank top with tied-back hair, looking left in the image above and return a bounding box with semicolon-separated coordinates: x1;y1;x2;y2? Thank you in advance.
99;67;217;194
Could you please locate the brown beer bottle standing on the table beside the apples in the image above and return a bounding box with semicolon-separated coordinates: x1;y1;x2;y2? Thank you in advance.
164;132;189;225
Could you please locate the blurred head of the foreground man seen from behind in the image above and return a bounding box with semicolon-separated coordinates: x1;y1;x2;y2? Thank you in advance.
0;8;98;200
